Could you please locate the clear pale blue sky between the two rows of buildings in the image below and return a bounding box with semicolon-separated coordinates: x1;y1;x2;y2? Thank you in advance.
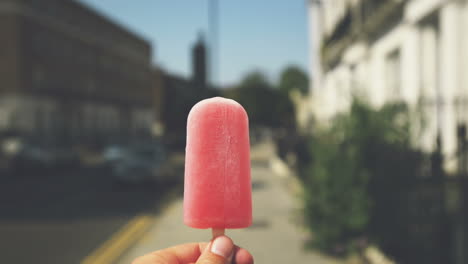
80;0;308;85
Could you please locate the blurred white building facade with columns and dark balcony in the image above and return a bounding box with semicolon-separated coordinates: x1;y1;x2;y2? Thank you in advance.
309;0;468;171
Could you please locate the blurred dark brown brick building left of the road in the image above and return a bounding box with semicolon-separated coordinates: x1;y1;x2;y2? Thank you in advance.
0;0;154;143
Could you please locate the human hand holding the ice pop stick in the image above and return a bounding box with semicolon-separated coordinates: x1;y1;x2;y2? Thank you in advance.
132;236;253;264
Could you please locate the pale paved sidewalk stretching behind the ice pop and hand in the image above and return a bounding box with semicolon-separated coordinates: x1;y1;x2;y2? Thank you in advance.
117;141;337;264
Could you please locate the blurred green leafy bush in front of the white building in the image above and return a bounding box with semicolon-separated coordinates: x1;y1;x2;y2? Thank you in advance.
299;100;422;253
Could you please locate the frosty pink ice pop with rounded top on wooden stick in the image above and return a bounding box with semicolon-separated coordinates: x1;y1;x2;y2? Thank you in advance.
184;97;252;230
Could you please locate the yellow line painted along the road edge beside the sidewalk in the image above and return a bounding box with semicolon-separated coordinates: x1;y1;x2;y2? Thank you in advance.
81;215;154;264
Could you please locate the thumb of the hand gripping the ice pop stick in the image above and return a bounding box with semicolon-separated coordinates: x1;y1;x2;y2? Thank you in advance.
196;236;234;264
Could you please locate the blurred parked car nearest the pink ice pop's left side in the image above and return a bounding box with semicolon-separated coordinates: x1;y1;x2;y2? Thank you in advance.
107;142;171;185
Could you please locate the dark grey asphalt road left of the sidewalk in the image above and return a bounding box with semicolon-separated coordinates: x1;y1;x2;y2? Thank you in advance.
0;168;181;264
